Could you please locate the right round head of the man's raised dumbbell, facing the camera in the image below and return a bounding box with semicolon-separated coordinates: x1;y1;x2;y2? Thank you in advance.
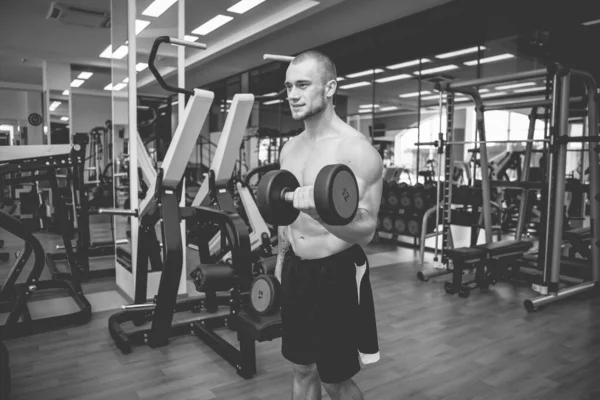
314;164;358;225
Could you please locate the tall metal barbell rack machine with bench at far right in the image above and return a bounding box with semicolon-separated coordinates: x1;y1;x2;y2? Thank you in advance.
417;64;600;311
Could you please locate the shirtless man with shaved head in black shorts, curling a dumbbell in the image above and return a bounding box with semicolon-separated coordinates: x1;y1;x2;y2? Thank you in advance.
275;51;383;400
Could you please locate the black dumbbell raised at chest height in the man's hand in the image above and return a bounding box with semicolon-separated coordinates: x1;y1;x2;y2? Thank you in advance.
256;164;358;226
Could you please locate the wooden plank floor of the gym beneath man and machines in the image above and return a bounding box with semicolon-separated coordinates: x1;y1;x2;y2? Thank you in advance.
0;220;600;400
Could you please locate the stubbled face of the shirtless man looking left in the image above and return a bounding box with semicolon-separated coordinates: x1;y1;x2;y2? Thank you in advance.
285;59;328;121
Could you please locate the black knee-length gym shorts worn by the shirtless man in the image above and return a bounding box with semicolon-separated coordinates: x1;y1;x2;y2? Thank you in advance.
281;246;362;383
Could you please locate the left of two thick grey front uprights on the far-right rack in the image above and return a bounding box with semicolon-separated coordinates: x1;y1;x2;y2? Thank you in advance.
546;73;571;293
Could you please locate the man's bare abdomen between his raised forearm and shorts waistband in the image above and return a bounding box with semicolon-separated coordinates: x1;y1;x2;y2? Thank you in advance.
287;213;352;260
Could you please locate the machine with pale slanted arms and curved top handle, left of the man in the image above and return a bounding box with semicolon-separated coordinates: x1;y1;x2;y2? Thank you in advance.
101;37;280;378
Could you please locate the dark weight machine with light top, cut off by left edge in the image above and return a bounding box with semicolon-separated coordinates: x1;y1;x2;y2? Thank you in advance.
0;144;92;339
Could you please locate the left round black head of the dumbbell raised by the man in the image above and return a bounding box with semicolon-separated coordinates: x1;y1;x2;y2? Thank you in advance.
256;169;300;226
